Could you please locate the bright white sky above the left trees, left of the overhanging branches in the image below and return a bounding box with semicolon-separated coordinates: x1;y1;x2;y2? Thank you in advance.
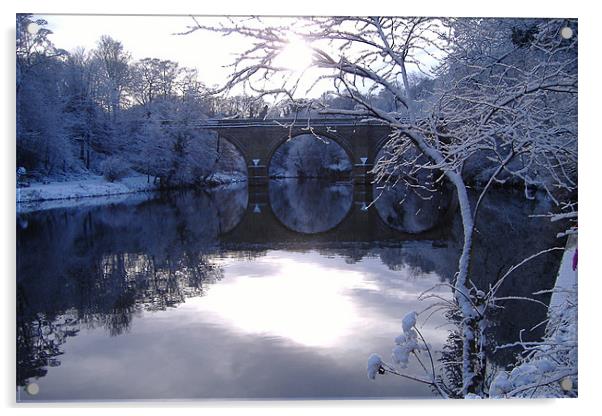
36;15;246;86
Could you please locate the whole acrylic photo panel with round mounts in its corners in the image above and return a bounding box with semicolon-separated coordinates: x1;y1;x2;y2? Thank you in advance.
16;14;578;402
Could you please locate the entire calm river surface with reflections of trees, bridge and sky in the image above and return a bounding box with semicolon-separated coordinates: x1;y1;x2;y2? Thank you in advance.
16;180;564;401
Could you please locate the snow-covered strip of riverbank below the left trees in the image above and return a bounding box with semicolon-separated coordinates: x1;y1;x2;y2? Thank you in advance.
16;174;242;213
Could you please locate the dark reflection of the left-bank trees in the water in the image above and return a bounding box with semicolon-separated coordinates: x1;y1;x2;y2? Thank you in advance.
17;188;246;385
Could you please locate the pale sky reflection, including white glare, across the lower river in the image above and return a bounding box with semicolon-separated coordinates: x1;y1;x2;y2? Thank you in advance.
21;251;446;400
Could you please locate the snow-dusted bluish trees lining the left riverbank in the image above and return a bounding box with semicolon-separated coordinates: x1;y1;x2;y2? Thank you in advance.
16;14;245;185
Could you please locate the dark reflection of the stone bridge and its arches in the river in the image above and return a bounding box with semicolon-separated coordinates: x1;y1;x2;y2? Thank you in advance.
221;179;454;246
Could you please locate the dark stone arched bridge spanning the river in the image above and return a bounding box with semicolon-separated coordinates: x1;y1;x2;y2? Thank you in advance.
199;117;391;184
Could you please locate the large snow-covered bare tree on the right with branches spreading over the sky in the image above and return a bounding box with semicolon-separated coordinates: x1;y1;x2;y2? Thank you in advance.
188;17;577;396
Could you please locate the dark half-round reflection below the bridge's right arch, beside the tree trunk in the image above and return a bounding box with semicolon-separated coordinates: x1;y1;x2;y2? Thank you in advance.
373;183;452;234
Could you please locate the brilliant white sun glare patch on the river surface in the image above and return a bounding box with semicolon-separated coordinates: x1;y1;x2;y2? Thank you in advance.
191;253;376;347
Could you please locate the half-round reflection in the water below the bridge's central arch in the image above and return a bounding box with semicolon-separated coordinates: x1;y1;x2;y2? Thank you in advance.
269;180;353;234
